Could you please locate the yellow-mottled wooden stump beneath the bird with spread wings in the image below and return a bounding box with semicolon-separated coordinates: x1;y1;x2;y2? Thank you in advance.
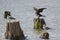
34;18;46;29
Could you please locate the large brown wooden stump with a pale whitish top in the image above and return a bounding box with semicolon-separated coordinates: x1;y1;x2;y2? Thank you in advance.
5;20;24;40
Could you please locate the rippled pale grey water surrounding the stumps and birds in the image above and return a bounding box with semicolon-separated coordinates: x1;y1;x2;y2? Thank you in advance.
0;0;60;40
